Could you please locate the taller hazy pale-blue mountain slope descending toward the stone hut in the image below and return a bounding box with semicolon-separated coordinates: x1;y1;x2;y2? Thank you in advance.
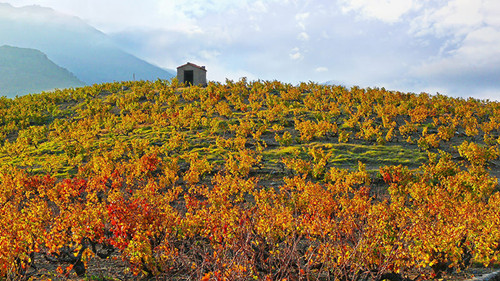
0;3;174;84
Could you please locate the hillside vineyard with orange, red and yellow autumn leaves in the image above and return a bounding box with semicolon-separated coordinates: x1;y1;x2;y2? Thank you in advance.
0;79;500;281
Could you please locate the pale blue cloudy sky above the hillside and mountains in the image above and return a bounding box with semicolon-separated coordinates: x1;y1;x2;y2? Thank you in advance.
0;0;500;100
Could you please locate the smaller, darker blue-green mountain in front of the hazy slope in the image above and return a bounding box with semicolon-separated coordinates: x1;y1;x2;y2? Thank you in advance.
0;46;85;97
